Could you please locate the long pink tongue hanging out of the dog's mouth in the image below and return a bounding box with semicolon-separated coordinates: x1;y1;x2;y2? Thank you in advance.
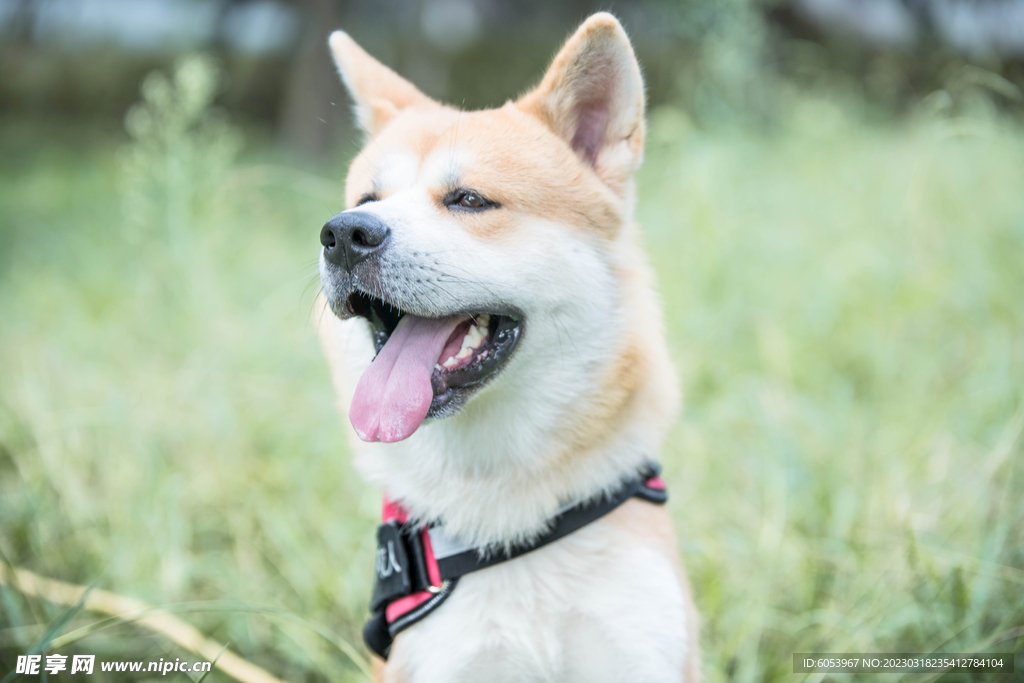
348;313;462;442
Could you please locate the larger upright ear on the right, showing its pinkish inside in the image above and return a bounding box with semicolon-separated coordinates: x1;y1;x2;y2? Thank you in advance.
516;12;644;194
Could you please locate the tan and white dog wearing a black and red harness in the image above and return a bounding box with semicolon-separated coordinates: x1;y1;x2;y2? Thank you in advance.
318;12;699;683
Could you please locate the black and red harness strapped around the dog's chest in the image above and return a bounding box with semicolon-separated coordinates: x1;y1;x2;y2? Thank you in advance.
362;463;668;659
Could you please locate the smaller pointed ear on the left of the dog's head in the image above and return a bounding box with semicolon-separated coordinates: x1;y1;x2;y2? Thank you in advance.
328;31;435;135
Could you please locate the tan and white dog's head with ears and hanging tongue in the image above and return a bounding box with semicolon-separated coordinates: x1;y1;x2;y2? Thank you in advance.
319;13;658;448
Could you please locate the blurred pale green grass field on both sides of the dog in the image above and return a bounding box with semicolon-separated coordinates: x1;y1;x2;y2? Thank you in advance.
0;60;1024;683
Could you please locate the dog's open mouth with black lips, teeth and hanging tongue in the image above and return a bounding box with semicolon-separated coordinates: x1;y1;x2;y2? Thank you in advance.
345;291;522;441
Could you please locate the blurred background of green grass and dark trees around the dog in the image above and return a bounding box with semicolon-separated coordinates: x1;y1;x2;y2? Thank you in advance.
0;0;1024;683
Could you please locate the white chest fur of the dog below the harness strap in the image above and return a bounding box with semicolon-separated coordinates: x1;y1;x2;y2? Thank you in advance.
384;501;691;683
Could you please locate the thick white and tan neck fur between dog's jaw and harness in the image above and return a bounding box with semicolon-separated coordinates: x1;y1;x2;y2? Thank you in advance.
356;297;677;546
